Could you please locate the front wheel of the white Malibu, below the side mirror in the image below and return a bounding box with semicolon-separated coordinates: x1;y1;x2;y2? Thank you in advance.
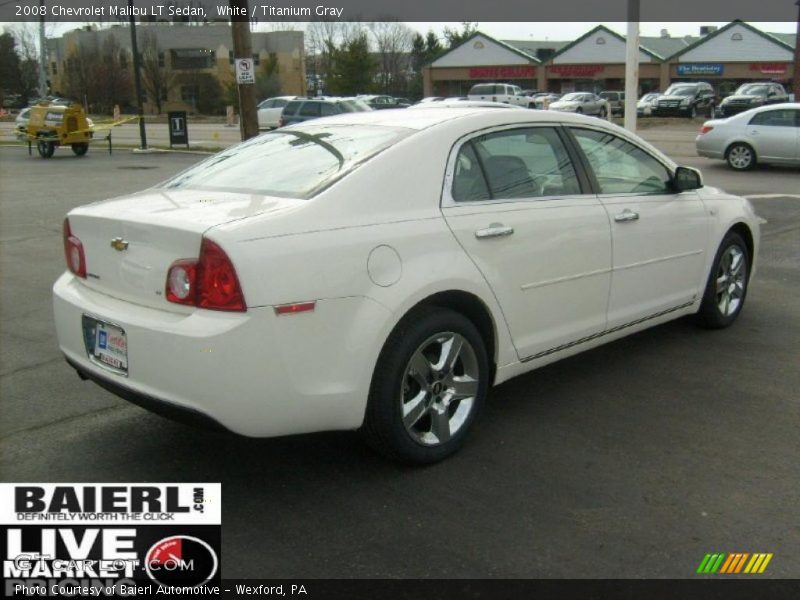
697;231;750;329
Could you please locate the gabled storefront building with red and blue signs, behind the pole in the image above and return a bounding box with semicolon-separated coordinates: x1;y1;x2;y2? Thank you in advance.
423;21;794;96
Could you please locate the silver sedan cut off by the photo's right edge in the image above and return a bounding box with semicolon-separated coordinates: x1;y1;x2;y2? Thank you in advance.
695;103;800;171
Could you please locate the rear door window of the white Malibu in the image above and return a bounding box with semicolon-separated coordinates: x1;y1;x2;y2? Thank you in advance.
453;127;580;202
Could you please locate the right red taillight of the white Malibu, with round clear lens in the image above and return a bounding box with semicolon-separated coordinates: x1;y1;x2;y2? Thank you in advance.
166;238;247;312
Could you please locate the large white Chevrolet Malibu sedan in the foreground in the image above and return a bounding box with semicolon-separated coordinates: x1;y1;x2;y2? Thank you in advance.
54;107;759;463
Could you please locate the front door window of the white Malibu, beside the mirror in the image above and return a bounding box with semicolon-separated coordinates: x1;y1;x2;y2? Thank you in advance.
572;128;672;194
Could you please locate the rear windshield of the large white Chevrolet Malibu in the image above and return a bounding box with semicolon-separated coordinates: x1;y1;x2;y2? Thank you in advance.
162;125;413;199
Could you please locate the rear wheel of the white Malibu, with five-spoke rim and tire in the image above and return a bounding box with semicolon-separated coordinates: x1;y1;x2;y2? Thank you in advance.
362;307;489;464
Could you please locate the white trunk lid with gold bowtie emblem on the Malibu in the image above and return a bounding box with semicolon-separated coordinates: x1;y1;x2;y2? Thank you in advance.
68;189;306;311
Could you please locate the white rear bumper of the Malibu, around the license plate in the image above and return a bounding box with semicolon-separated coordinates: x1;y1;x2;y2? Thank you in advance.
53;273;390;437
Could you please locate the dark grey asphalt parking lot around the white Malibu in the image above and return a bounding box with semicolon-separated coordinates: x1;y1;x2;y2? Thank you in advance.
0;125;800;578
